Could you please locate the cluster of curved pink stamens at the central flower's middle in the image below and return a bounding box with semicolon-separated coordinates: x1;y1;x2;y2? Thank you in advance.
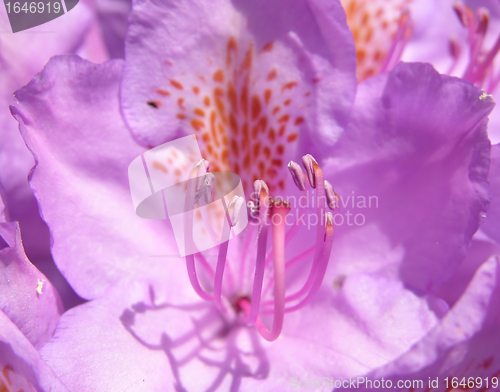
182;155;337;341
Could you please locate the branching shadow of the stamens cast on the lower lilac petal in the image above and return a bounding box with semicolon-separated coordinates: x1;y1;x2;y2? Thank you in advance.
120;286;269;391
